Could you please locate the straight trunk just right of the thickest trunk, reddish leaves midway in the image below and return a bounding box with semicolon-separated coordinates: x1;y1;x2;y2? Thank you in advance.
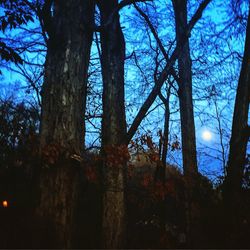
99;0;127;248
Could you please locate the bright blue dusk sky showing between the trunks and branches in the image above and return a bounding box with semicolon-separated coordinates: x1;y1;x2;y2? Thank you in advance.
0;0;250;184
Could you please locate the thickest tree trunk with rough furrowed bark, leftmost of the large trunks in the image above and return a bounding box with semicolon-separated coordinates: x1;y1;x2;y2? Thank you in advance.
37;0;94;248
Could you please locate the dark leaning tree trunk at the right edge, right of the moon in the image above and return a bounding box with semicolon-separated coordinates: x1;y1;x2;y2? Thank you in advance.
225;10;250;197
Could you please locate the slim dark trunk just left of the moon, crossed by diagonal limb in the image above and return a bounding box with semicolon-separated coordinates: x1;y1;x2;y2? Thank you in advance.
172;0;198;175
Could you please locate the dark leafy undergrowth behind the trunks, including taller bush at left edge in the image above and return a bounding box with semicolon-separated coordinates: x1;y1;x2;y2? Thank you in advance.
0;103;250;249
